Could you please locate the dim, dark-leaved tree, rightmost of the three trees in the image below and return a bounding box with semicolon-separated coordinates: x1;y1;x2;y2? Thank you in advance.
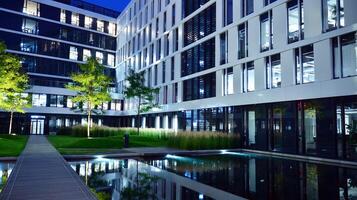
124;70;160;134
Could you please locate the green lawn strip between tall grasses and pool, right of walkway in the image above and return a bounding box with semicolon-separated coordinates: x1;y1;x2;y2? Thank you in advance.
48;135;167;155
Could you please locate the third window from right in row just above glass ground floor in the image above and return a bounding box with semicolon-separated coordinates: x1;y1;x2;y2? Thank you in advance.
265;54;281;89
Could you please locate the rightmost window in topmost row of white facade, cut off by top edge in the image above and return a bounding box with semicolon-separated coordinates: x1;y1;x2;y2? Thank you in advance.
323;0;345;31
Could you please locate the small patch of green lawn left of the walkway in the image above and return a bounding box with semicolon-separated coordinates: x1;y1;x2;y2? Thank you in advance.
0;135;28;157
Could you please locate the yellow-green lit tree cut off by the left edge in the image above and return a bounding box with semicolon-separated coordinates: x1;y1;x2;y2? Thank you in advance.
0;43;31;134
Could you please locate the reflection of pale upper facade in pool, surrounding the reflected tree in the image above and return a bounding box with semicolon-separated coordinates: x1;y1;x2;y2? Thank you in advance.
70;159;234;200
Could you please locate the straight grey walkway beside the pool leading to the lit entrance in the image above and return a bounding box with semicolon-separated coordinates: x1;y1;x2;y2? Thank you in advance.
0;136;95;200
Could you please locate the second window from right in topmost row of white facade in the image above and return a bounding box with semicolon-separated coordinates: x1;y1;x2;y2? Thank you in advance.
288;0;304;43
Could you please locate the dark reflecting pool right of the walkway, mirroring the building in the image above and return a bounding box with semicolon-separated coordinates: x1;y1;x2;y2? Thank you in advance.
69;152;357;200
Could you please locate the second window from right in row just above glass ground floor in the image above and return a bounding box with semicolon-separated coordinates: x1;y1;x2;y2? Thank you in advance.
295;45;315;84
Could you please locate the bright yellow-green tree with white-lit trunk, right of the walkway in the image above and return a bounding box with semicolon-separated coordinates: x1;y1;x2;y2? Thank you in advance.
66;58;111;137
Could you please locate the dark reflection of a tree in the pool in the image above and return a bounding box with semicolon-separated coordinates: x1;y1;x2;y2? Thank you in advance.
120;173;159;200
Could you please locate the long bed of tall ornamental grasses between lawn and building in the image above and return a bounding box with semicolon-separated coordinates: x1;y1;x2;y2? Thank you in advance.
53;126;240;150
